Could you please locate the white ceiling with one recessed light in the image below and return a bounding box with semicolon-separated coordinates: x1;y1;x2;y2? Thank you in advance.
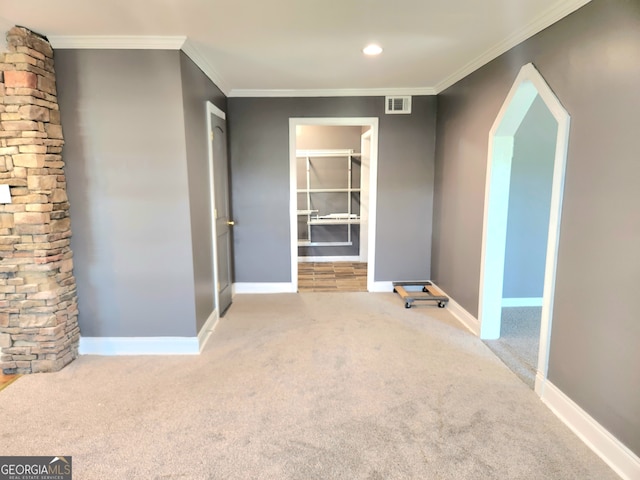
0;0;590;96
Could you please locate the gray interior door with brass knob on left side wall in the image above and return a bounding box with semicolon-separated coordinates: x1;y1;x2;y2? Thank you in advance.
211;113;233;315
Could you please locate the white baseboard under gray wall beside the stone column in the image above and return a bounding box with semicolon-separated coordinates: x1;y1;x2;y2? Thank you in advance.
79;337;200;356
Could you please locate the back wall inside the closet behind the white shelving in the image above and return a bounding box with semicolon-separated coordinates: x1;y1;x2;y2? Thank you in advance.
296;125;363;256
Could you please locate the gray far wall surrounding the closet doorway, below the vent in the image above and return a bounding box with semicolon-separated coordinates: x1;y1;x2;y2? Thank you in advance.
228;96;436;282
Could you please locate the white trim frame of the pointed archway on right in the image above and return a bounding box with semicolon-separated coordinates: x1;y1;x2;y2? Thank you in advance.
478;63;570;396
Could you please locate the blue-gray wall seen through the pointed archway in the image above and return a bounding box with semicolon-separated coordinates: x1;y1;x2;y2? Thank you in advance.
503;97;558;298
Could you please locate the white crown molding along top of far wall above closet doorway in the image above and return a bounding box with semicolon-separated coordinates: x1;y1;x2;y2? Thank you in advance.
228;87;437;97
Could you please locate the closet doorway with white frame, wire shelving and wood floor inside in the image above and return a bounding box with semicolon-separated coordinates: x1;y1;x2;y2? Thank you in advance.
289;118;378;291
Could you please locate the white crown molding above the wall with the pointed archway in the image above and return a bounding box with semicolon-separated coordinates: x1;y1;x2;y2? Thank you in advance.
434;0;591;94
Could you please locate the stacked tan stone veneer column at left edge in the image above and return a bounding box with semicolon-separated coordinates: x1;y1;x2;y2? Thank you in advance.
0;27;79;373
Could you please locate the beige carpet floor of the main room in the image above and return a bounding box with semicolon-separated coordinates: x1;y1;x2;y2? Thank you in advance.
0;293;617;480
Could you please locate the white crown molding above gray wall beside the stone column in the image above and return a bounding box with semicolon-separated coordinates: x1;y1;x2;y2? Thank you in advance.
47;35;187;50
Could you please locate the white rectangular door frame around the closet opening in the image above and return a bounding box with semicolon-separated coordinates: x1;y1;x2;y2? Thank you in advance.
289;117;379;292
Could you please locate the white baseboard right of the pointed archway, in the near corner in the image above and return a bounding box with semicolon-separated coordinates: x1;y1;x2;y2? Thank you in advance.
542;381;640;480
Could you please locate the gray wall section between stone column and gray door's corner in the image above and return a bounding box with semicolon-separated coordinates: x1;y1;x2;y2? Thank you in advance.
55;50;196;337
